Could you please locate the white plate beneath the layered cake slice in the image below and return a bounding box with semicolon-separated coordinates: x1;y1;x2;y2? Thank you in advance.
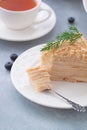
11;45;87;108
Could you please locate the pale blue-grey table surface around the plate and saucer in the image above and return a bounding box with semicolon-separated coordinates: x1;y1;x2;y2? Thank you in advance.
0;0;87;130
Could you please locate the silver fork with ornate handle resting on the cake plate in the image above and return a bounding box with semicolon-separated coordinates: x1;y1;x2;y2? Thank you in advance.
49;89;86;112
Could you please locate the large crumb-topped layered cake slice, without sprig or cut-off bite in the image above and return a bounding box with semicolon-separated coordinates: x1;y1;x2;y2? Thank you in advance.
41;37;87;82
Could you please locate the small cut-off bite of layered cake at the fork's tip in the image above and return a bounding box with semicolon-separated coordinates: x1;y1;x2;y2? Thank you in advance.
27;66;51;91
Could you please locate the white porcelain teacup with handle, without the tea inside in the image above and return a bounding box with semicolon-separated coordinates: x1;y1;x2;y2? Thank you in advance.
0;0;51;30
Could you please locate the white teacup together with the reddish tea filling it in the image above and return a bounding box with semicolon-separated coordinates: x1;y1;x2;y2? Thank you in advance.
0;0;51;30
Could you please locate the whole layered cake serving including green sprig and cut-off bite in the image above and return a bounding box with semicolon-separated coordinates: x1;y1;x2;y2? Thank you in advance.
27;26;87;91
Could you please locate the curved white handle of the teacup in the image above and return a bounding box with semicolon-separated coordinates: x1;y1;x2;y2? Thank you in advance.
34;8;52;24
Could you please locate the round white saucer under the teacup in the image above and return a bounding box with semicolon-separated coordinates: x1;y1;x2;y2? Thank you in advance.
0;3;56;41
